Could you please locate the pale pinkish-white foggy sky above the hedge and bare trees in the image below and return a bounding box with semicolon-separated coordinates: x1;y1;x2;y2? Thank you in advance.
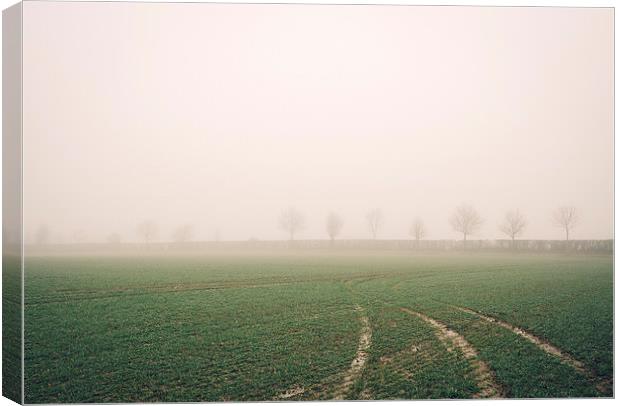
23;2;613;242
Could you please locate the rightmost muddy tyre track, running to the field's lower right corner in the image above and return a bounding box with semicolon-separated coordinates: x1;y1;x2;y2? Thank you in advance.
451;305;613;395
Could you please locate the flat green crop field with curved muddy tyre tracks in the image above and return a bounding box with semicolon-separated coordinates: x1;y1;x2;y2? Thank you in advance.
25;251;613;403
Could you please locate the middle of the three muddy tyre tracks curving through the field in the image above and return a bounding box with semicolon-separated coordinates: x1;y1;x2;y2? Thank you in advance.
400;307;504;399
